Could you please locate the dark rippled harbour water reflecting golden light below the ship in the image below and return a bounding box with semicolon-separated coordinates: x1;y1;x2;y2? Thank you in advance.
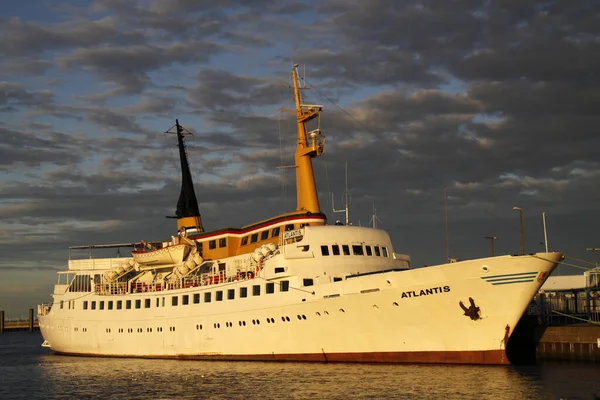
0;333;600;400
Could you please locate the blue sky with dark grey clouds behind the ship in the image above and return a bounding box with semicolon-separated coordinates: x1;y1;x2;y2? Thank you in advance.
0;0;600;316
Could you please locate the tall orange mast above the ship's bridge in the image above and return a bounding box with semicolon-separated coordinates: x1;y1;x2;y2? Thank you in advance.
292;64;325;213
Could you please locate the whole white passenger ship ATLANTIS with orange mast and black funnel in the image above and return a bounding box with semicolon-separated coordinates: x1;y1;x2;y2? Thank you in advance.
38;65;563;364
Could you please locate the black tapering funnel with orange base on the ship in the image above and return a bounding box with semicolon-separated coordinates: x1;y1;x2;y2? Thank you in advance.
165;119;204;233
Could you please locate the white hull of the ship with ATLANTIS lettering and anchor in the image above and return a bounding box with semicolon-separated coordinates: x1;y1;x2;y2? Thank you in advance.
39;253;562;364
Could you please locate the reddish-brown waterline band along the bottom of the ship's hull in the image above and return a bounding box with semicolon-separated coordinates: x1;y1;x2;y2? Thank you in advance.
56;350;510;365
